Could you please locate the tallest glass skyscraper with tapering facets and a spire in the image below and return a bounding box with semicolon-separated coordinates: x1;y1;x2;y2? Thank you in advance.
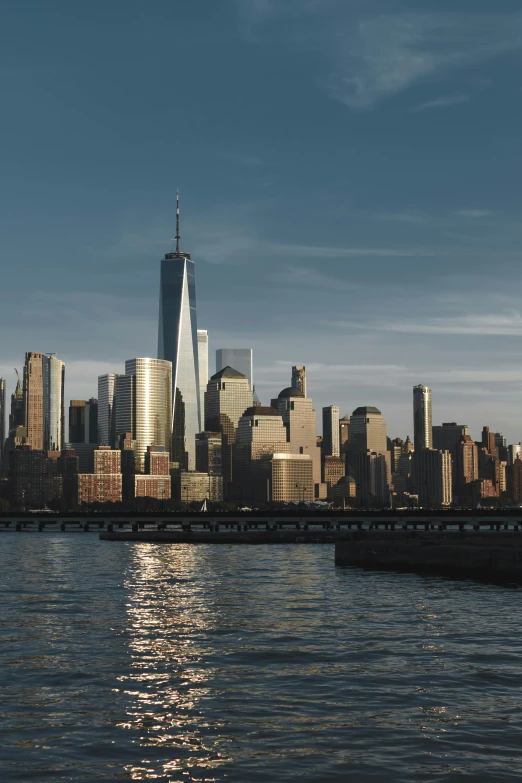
158;192;199;470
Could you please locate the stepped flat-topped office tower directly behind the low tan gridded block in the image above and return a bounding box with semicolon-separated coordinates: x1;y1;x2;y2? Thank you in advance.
233;406;291;505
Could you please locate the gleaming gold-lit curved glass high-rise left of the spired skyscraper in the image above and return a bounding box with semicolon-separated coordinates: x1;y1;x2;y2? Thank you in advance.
115;358;172;473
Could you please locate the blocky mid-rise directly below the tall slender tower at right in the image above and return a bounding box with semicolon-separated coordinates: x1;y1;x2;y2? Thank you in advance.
412;449;453;508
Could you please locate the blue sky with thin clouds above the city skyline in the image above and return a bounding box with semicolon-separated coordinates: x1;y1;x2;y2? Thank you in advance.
0;0;522;443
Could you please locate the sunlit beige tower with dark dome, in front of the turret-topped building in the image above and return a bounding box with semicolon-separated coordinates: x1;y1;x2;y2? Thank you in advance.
272;386;321;484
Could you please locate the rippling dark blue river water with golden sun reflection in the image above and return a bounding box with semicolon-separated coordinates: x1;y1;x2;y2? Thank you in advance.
0;533;522;783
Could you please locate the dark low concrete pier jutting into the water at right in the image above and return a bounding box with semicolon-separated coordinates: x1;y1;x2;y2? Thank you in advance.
335;530;522;583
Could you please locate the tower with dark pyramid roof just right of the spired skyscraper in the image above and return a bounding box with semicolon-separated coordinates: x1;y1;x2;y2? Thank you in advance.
205;366;252;495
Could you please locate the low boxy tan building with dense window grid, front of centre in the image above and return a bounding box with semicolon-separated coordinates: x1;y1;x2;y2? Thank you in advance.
259;452;315;503
